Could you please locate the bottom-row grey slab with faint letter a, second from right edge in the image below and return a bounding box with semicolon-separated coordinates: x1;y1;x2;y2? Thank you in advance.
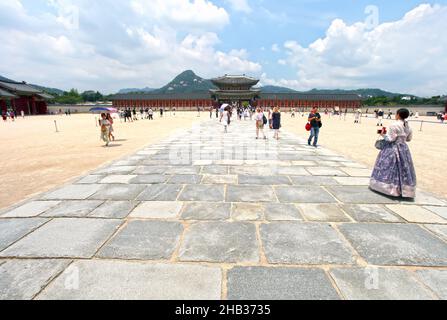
330;268;433;300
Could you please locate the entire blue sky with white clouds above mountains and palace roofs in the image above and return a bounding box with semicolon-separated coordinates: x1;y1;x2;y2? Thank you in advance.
0;0;447;96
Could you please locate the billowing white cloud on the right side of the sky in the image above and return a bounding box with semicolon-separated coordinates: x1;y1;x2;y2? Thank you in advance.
263;4;447;95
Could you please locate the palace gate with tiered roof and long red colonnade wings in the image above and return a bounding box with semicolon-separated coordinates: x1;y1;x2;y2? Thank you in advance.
111;75;362;111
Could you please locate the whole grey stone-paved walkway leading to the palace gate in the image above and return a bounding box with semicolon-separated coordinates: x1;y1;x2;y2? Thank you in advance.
0;120;447;300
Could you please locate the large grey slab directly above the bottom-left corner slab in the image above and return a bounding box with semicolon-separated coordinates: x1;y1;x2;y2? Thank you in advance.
0;218;121;258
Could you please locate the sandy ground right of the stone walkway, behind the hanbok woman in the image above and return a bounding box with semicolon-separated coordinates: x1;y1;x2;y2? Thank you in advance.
283;114;447;198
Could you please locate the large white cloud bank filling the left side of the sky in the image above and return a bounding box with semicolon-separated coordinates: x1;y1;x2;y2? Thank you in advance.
0;0;261;93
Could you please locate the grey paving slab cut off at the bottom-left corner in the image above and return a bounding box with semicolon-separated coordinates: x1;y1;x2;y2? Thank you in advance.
0;260;70;300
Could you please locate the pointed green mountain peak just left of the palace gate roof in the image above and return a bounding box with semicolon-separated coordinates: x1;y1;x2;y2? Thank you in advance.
153;70;216;93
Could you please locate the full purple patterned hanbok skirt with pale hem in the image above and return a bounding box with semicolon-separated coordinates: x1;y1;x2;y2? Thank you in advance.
370;142;416;198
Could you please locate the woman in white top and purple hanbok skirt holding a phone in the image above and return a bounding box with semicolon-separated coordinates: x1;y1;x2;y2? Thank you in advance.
370;109;416;198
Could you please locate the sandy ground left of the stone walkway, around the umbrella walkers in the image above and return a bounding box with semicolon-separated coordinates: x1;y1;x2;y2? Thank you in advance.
0;112;206;208
